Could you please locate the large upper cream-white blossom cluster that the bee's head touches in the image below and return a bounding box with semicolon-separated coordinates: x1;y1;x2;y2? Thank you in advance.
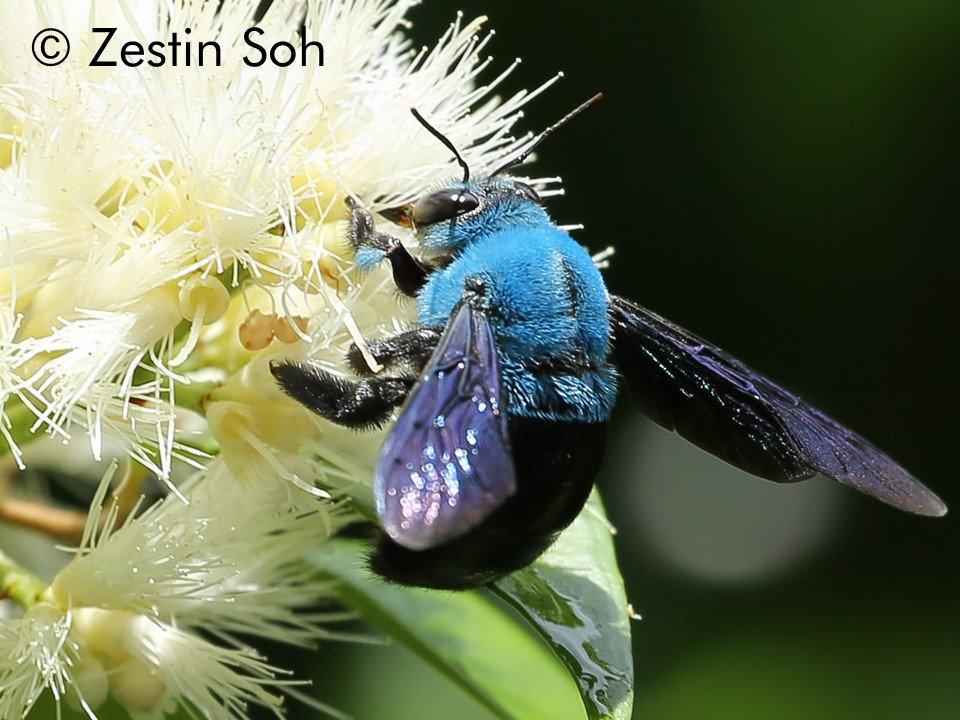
0;0;552;477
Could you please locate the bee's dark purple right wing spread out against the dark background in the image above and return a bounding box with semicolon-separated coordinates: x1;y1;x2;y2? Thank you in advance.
611;297;947;515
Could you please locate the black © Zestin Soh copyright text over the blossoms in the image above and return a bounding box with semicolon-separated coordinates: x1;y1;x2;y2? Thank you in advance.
32;27;323;67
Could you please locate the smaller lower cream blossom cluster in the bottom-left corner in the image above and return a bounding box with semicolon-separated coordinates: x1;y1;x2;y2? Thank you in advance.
0;462;332;718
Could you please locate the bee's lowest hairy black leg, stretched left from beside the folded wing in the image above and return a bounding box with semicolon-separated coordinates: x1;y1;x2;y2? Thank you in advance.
270;362;414;429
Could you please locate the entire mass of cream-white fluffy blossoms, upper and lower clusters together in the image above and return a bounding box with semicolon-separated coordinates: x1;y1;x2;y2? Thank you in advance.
0;0;560;718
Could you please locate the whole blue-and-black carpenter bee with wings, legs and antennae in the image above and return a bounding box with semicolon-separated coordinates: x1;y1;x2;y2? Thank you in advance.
272;95;946;589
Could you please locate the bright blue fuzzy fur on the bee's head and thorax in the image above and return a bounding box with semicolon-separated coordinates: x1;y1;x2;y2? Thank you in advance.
417;178;617;422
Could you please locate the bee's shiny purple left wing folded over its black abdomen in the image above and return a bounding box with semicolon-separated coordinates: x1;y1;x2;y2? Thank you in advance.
374;302;516;550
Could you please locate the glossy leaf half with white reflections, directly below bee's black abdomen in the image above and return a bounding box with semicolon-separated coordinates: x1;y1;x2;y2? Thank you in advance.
492;491;633;720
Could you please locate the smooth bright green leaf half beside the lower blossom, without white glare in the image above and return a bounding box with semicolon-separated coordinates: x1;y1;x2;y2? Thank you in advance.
309;538;584;720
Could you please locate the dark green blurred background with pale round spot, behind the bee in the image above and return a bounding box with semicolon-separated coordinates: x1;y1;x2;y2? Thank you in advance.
319;0;960;720
